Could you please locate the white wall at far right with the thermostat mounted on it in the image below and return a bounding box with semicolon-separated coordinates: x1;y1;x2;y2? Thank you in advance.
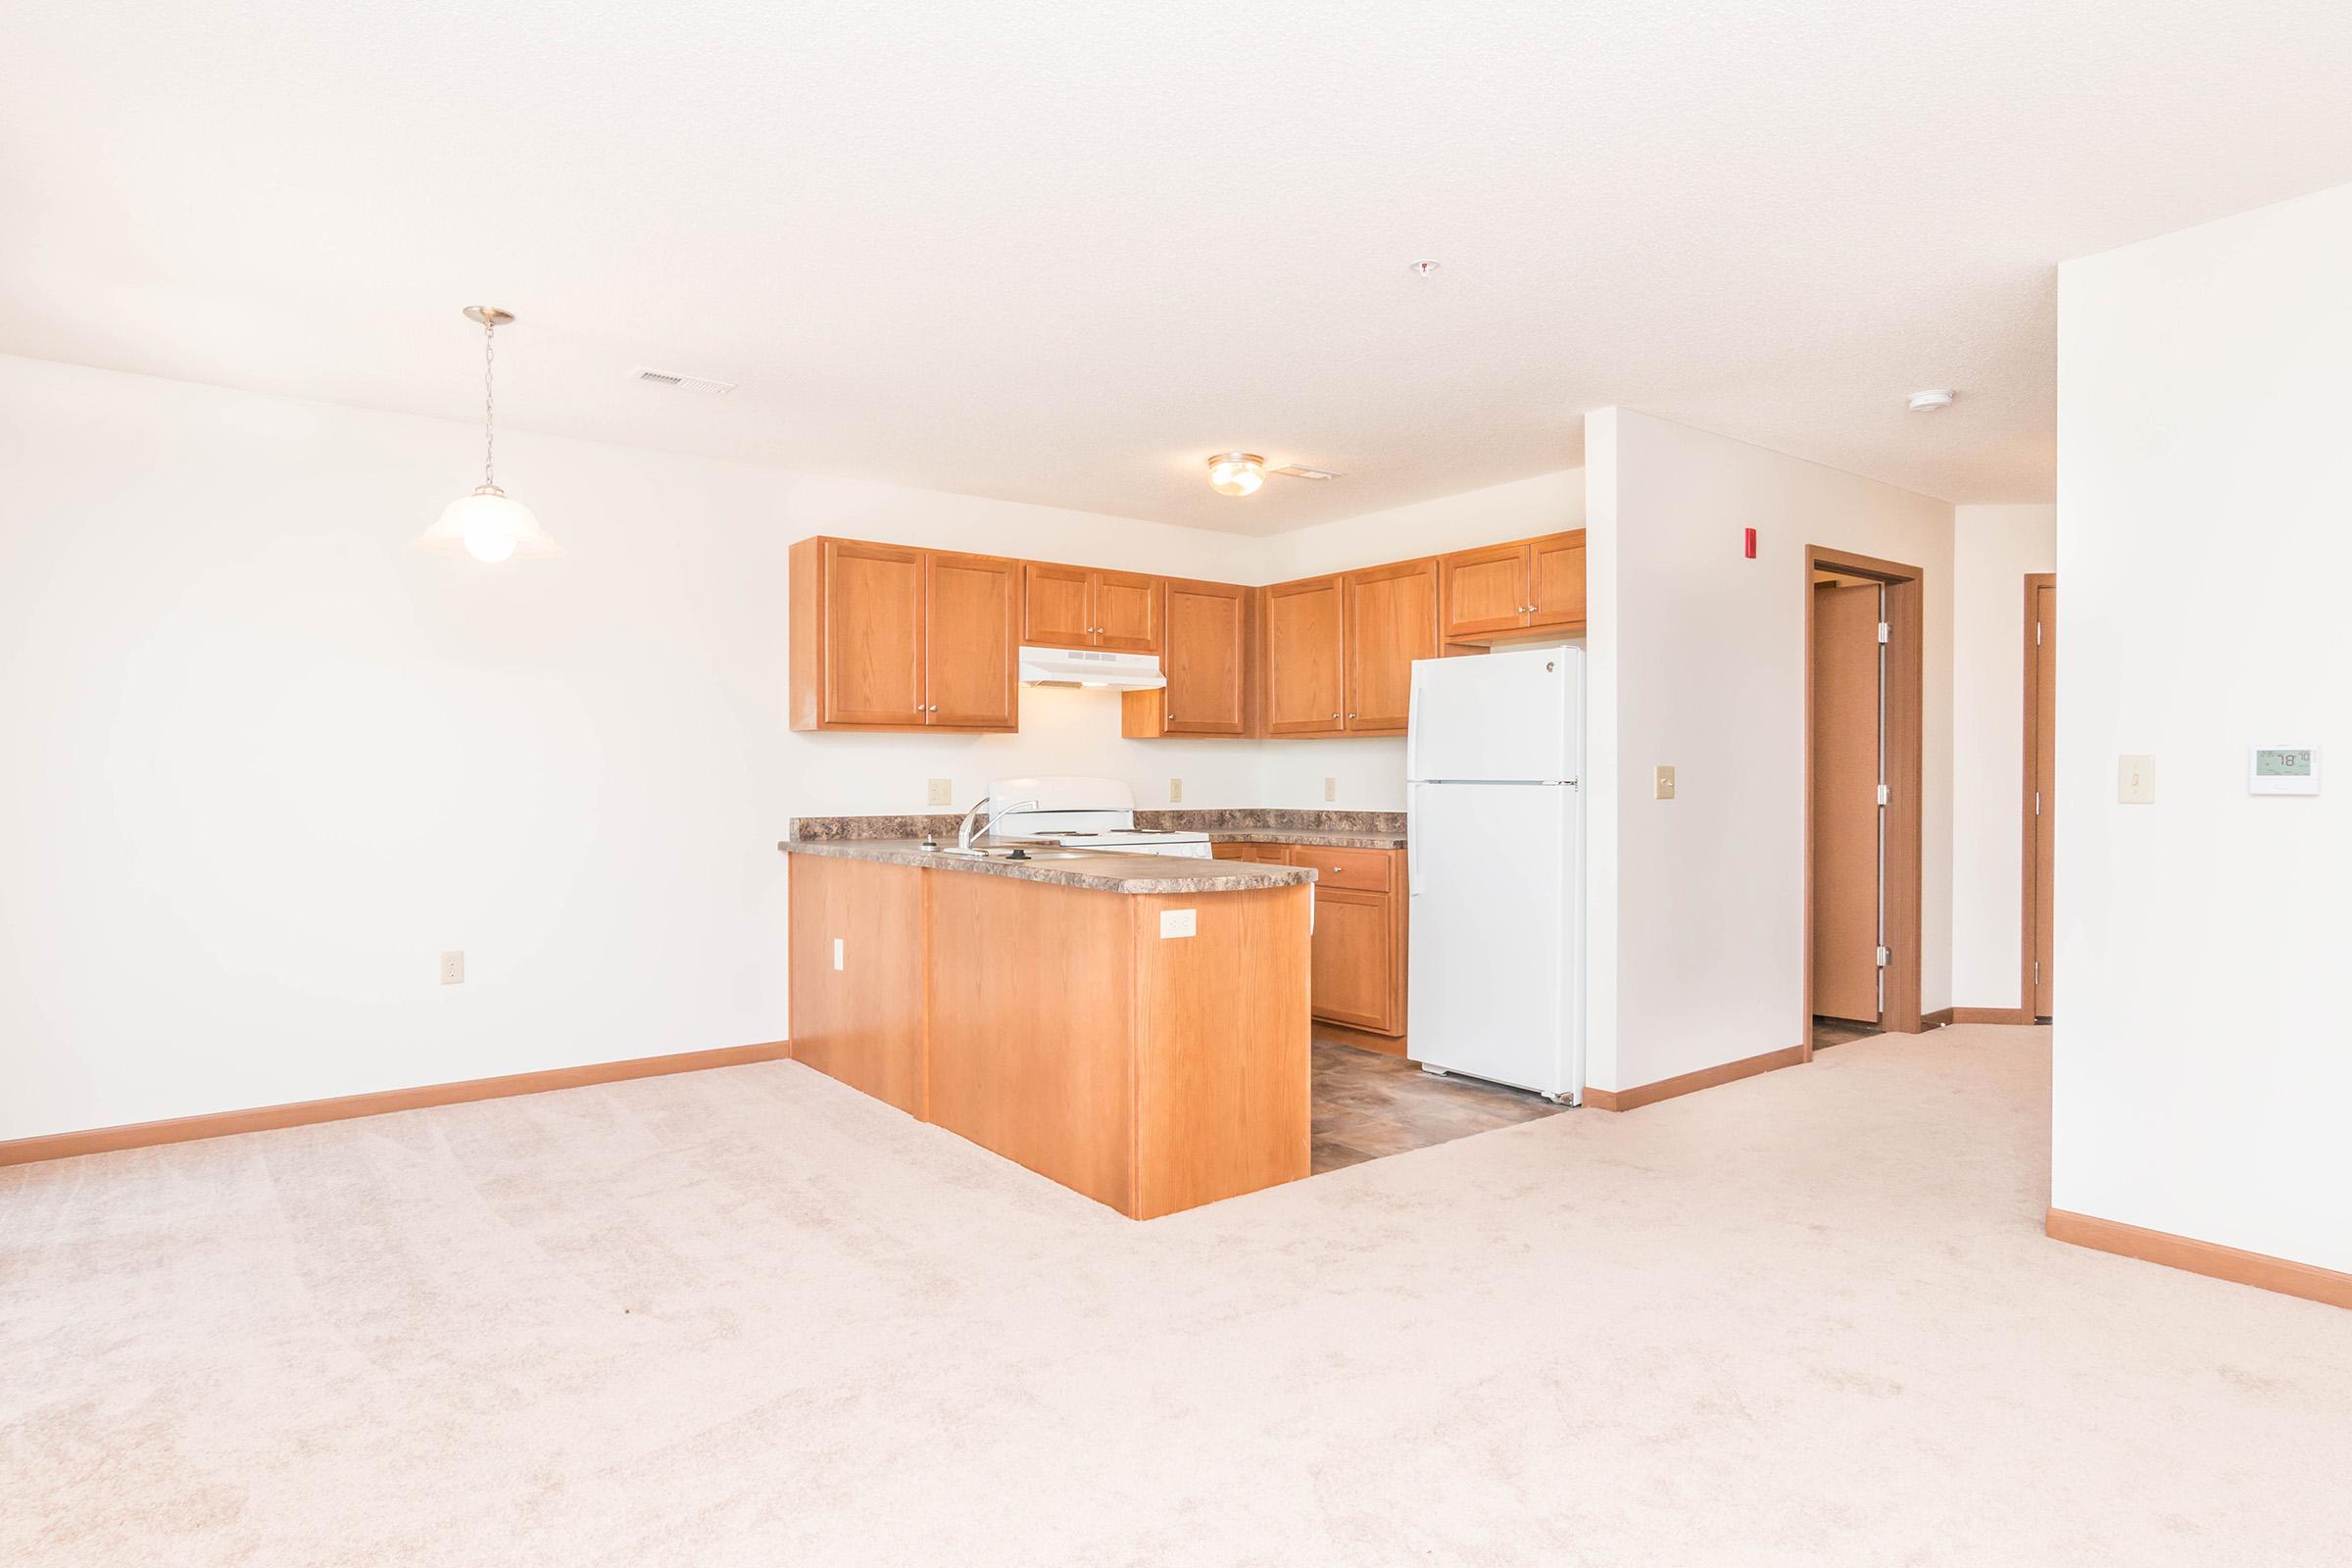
2051;186;2352;1269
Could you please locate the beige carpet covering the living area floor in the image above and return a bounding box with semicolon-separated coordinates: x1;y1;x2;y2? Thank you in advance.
0;1027;2352;1568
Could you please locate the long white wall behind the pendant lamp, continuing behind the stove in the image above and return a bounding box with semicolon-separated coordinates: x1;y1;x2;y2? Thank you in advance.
0;358;1289;1138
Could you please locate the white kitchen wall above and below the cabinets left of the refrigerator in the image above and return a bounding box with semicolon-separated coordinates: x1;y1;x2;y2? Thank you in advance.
1249;467;1586;811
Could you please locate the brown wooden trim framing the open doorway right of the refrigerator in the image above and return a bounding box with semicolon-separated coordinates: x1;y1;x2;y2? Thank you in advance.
1797;546;1927;1060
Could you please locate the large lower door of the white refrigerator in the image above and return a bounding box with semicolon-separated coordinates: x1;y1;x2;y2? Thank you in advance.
1406;783;1586;1101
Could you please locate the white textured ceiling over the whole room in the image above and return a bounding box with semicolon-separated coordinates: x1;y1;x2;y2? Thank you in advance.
0;0;2352;531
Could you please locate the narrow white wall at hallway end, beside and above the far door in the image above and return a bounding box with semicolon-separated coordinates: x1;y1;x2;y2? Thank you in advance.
1952;506;2058;1008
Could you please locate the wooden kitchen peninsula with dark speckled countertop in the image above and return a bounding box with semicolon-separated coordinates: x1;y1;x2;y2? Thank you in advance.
778;835;1315;1220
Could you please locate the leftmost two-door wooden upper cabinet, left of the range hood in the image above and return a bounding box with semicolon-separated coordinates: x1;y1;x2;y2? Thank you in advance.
790;538;1021;729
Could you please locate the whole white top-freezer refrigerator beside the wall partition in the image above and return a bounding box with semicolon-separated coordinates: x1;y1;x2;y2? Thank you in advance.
1404;647;1586;1104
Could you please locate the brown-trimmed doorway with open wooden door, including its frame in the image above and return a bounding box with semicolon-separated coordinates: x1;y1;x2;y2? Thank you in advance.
1804;546;1924;1060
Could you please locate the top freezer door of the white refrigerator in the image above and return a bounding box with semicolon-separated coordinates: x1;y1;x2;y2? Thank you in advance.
1404;649;1586;783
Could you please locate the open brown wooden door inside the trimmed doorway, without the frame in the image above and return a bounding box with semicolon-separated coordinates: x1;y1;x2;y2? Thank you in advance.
1811;583;1882;1022
